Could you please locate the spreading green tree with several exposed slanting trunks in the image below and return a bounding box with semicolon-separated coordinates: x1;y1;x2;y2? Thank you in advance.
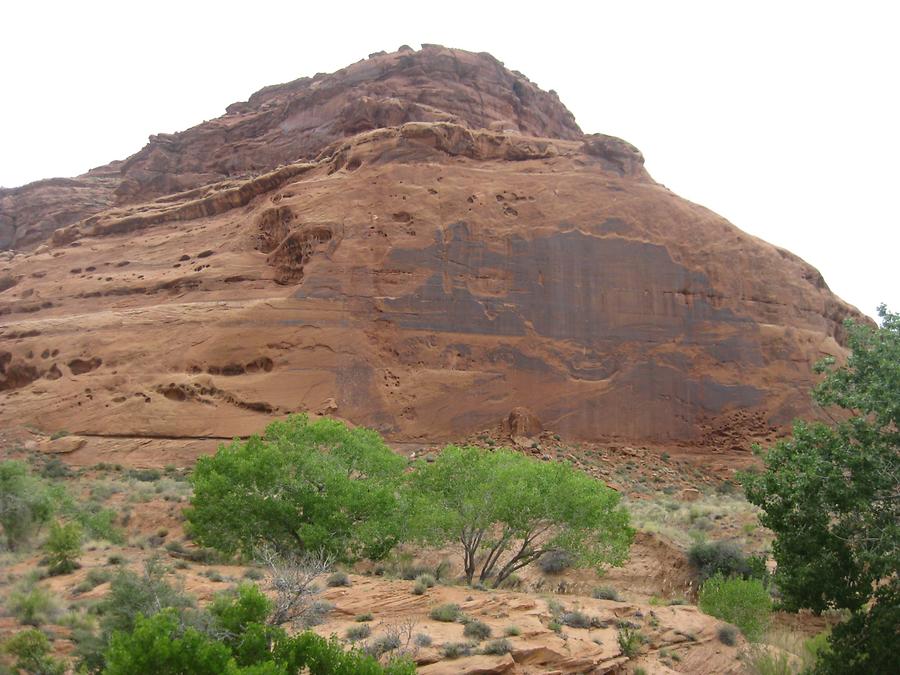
409;446;634;585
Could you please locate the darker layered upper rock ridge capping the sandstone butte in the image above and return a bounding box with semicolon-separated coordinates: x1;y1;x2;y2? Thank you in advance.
0;45;581;249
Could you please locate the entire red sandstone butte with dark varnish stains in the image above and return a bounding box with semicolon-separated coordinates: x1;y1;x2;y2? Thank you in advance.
0;45;861;464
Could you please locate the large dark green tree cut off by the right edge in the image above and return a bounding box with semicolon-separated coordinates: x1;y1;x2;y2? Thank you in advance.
743;306;900;673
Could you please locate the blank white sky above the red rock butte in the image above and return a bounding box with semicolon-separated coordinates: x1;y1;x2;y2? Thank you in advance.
0;0;900;315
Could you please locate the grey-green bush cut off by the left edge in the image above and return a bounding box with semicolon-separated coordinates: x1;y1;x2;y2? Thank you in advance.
0;460;60;551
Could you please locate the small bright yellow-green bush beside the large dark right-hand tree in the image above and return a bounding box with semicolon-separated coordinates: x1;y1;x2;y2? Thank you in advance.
698;574;772;640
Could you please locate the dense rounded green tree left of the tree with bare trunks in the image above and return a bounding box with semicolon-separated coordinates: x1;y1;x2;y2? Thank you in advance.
185;415;406;559
